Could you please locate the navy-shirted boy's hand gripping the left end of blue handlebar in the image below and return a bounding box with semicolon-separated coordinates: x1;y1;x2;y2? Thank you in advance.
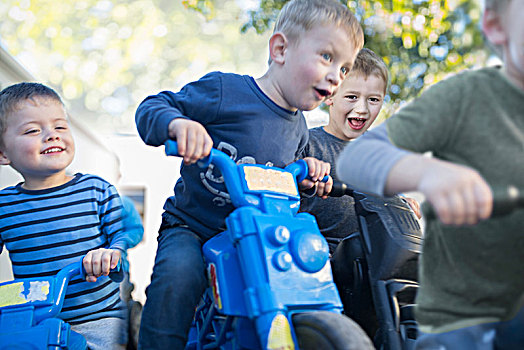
168;118;213;165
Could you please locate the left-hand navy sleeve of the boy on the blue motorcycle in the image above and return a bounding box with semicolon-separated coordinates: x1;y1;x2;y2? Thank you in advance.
135;72;222;146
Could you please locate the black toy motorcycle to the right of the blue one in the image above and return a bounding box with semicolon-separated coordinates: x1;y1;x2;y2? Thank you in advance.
330;183;524;350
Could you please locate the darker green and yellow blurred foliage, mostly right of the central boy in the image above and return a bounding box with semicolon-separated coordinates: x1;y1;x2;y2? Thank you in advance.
185;0;489;119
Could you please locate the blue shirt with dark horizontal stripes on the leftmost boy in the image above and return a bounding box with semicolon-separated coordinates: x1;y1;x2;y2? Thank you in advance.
0;174;129;324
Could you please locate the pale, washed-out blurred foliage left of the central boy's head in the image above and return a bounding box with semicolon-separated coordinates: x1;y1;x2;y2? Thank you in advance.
0;0;269;132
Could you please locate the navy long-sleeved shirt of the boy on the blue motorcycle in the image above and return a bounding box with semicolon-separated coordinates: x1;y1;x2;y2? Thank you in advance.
136;72;308;239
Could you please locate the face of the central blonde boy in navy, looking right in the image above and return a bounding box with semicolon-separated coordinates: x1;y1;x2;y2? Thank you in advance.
275;24;358;111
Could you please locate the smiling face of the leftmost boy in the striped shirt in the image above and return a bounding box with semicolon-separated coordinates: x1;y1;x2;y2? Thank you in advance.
0;97;75;181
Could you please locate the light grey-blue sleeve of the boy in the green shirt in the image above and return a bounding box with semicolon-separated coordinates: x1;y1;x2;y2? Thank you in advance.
337;122;409;196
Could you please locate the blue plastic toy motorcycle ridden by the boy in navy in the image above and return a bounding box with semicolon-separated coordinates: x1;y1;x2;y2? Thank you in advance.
166;141;373;350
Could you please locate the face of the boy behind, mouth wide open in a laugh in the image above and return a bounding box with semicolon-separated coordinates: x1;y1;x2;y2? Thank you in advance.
324;74;386;141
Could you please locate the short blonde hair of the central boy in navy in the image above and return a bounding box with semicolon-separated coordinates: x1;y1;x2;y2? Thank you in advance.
273;0;364;49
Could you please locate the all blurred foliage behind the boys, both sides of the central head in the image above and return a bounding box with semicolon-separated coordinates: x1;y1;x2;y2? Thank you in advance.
0;0;488;132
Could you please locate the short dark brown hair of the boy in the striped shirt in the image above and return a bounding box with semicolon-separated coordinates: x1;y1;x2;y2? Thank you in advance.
0;82;64;148
